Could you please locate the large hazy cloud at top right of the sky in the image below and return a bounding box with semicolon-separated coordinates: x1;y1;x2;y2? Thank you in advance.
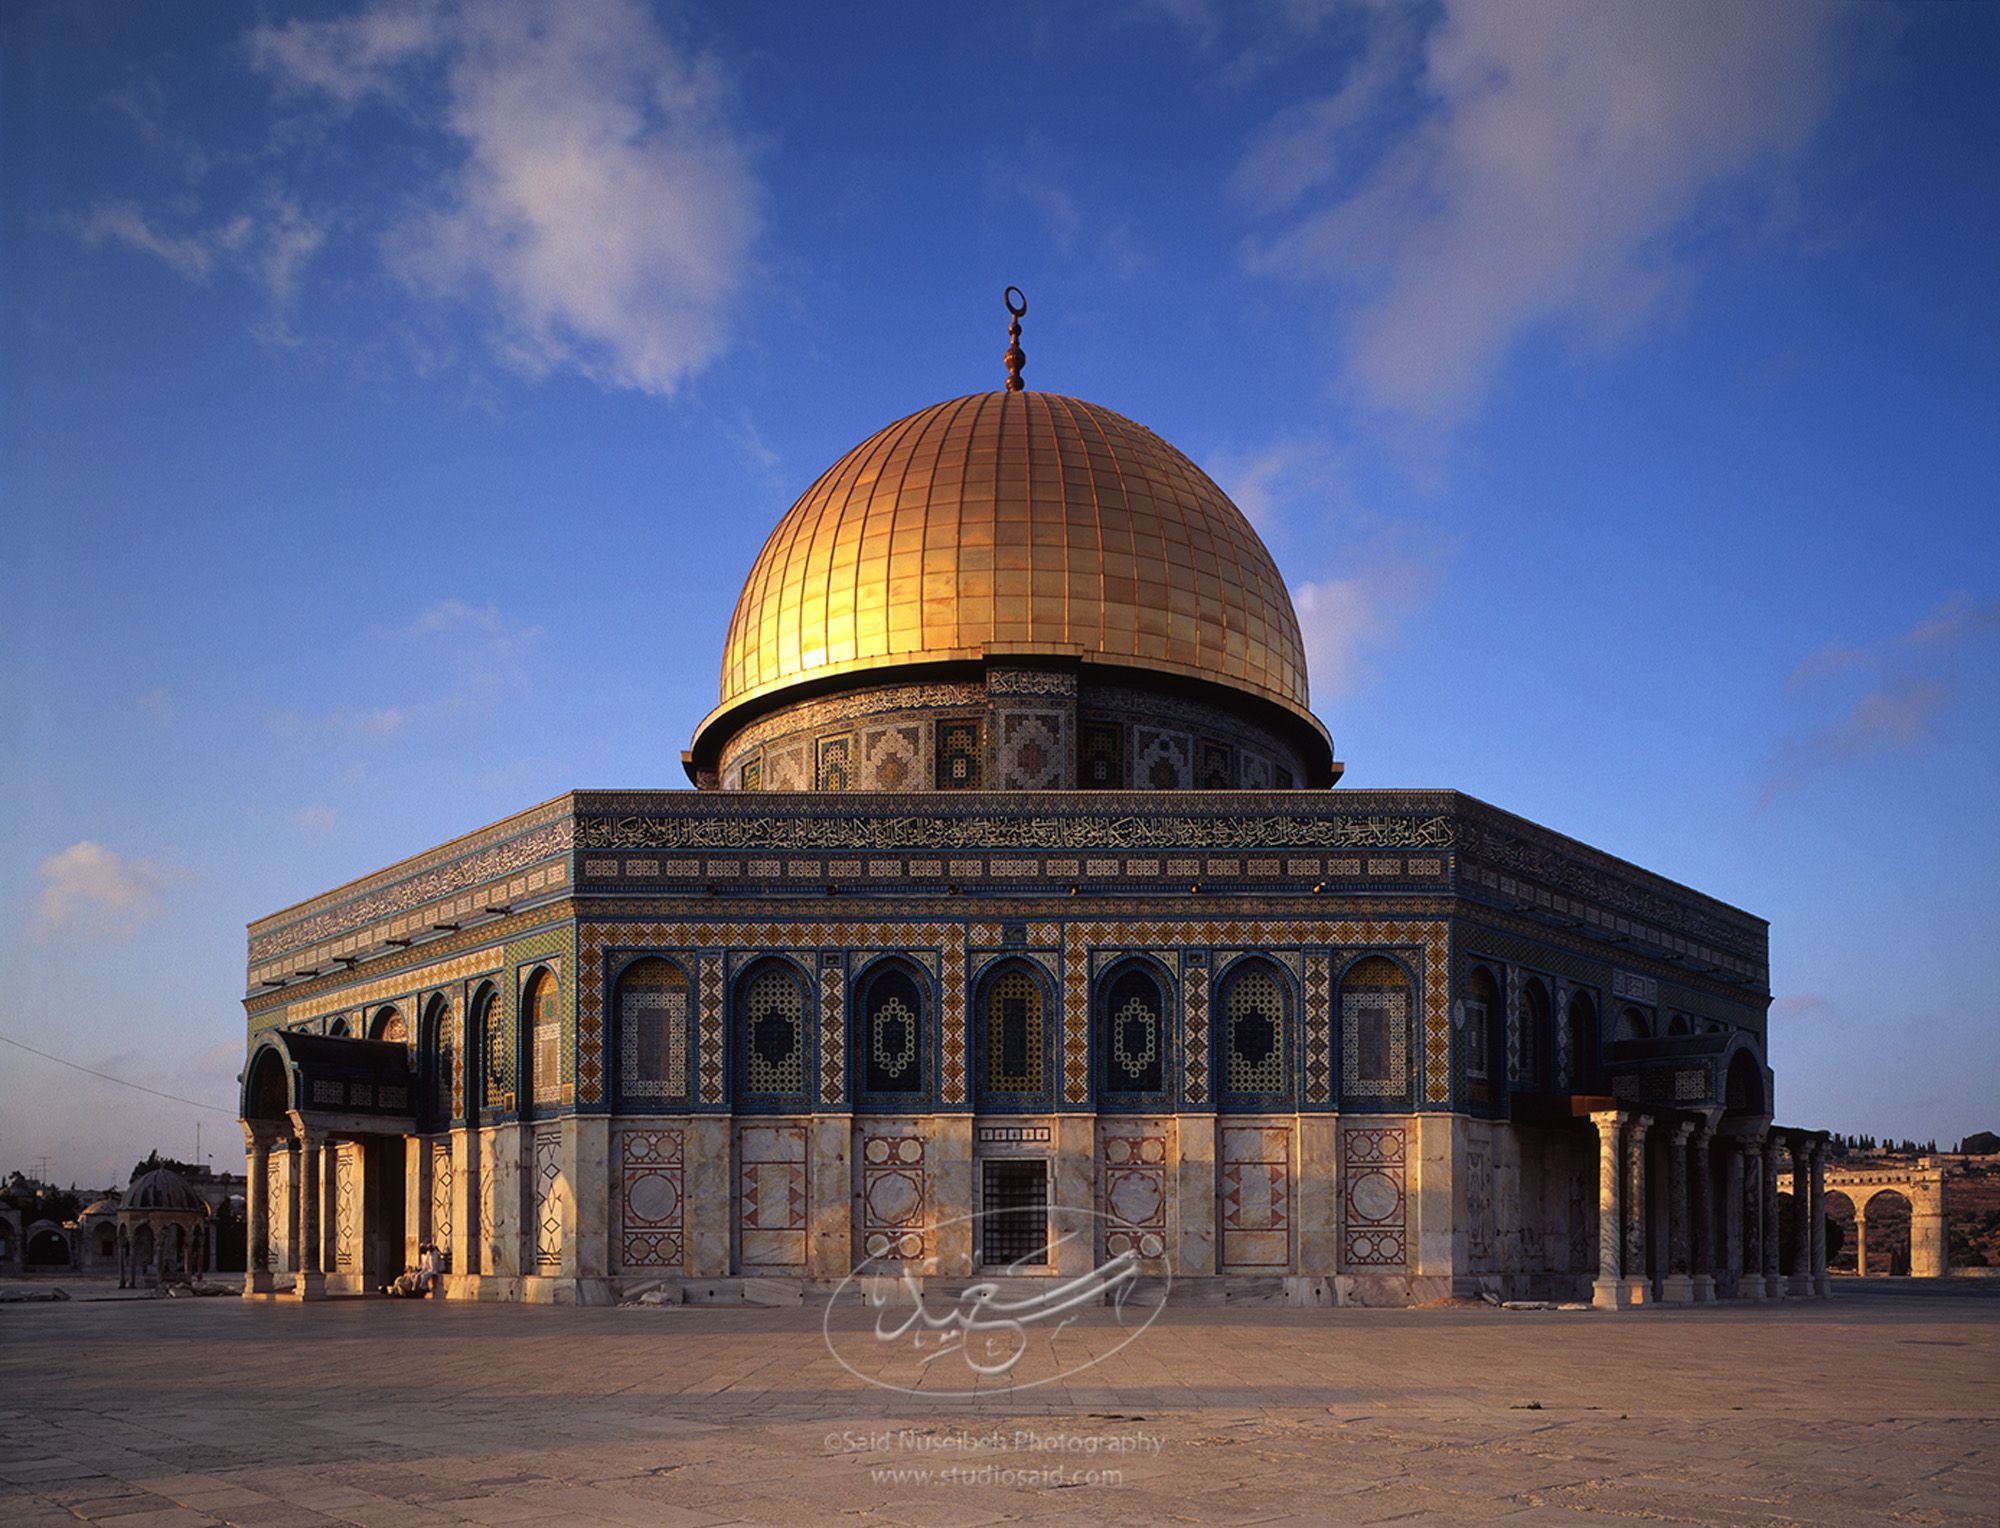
1236;0;1848;426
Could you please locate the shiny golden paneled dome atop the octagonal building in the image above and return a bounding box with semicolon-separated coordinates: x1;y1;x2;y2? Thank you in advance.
700;392;1324;756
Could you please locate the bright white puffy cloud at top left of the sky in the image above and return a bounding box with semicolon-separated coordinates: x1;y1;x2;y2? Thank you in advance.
250;0;764;394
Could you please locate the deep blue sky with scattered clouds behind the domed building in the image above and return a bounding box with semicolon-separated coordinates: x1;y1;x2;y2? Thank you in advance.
0;0;2000;1182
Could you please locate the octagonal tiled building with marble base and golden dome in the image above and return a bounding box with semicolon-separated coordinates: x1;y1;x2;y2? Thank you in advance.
242;328;1824;1306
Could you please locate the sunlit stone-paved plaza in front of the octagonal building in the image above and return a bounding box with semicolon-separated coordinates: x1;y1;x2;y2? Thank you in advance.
0;1280;2000;1528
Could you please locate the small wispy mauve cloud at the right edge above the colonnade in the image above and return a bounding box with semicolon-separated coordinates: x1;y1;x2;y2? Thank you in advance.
1760;594;2000;806
